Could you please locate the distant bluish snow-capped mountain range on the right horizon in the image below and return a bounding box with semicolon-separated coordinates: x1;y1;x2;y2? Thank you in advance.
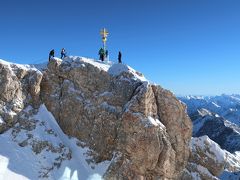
179;95;240;152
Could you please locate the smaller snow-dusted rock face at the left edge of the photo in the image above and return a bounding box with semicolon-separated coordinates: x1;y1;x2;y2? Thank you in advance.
0;60;42;133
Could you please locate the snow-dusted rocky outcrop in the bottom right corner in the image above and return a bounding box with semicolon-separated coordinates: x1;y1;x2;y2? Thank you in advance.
181;136;240;180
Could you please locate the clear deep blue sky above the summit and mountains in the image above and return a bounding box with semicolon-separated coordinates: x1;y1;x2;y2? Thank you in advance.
0;0;240;95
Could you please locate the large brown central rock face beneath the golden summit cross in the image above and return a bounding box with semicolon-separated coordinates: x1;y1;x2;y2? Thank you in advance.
41;58;192;179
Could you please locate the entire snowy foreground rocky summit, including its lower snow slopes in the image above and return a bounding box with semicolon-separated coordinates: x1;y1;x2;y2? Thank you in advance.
0;57;240;180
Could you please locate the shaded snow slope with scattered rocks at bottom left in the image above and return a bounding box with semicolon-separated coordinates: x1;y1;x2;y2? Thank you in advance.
0;105;111;180
